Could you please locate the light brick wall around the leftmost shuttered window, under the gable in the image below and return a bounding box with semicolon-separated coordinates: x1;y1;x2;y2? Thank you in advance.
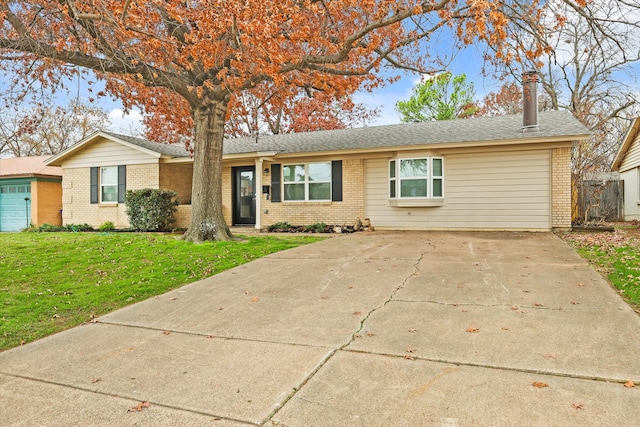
62;164;159;228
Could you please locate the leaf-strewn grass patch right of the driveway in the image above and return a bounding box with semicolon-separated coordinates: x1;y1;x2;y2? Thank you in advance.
560;225;640;313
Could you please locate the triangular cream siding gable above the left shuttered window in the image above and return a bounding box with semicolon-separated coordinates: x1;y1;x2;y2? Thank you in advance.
62;139;158;168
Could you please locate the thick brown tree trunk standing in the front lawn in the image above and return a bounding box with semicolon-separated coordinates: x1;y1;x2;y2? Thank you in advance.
183;99;233;242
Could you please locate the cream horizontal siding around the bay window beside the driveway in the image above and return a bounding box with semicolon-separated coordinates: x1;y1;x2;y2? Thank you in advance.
366;150;551;230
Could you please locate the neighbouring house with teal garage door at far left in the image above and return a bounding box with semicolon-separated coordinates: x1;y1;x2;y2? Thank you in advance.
0;156;62;231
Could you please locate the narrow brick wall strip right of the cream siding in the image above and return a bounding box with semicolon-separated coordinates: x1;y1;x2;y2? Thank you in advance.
551;147;571;228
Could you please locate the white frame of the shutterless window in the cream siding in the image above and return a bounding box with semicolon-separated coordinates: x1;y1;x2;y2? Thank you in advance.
387;156;445;206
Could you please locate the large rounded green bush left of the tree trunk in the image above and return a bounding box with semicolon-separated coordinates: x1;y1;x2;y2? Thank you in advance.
124;188;178;231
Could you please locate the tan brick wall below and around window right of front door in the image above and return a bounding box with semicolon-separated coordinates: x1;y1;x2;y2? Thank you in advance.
256;159;365;228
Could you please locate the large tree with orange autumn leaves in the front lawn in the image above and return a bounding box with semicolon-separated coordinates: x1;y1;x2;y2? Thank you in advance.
0;0;568;241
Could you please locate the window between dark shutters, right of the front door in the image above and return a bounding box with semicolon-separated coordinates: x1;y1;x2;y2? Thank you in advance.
282;162;331;201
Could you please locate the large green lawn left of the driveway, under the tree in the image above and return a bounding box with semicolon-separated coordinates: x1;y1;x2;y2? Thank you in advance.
0;233;322;351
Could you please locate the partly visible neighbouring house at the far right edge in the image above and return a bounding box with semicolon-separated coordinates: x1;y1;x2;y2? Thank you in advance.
611;118;640;221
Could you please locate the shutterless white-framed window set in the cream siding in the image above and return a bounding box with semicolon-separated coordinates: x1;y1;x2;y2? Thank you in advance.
389;157;444;199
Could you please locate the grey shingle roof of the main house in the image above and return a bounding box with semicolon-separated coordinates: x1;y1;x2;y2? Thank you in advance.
104;111;589;157
